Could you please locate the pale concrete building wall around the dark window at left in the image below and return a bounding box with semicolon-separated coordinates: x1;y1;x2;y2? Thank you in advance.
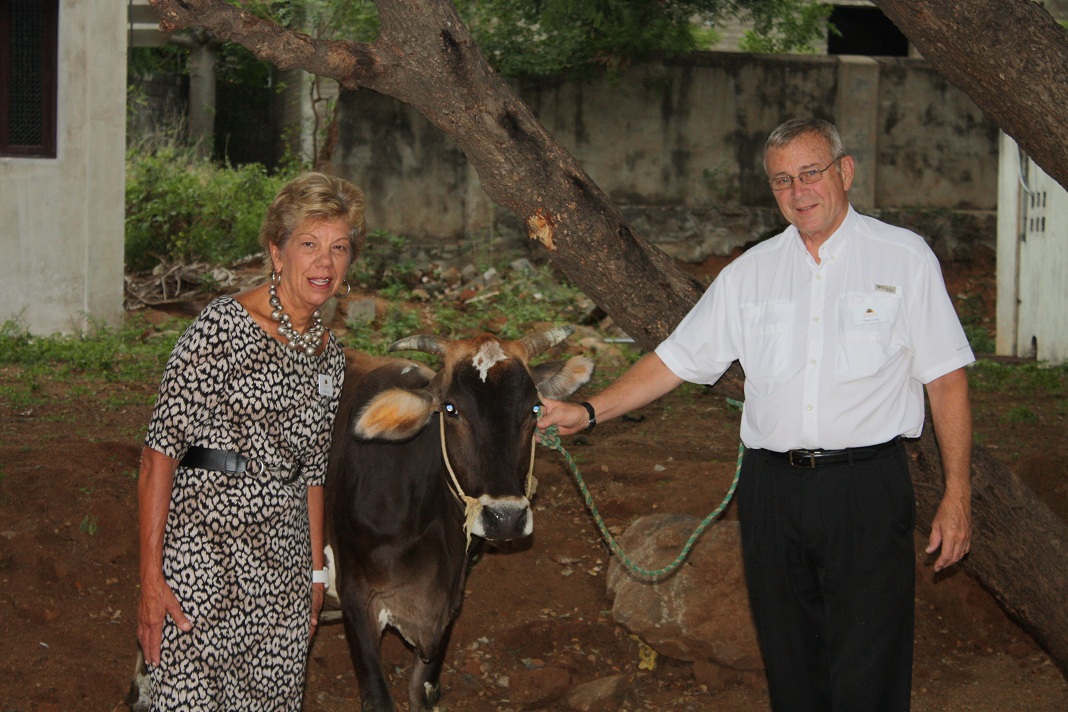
0;0;127;334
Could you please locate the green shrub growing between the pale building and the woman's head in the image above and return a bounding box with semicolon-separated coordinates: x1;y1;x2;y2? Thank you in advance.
126;145;296;271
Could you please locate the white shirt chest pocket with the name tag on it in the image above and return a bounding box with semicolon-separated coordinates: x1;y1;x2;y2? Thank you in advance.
835;294;901;378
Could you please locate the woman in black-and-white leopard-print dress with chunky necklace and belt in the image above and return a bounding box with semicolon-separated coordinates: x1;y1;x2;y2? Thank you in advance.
138;173;364;712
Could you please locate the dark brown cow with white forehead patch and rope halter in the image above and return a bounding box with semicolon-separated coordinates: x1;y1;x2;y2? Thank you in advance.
326;328;593;711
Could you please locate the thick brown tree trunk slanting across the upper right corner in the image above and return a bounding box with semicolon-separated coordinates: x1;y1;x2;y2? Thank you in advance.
873;0;1068;187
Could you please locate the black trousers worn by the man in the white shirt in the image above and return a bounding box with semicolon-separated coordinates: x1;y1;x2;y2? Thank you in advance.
738;443;915;712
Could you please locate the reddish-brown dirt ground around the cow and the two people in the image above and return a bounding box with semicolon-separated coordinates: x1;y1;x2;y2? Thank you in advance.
0;246;1068;712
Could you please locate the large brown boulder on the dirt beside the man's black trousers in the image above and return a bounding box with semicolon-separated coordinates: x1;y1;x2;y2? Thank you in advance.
608;515;764;670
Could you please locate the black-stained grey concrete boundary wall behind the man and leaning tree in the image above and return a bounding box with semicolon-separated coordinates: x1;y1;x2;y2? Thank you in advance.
334;53;998;262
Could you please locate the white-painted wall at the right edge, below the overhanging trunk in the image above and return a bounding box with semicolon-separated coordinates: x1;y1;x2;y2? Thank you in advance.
996;133;1068;364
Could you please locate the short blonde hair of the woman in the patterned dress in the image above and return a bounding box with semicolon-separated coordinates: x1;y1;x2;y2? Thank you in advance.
260;173;366;264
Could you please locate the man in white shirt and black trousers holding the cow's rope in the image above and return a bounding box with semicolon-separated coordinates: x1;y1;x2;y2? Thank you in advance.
539;120;974;712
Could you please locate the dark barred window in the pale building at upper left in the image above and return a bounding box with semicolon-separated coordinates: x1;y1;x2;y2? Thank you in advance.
0;0;59;158
